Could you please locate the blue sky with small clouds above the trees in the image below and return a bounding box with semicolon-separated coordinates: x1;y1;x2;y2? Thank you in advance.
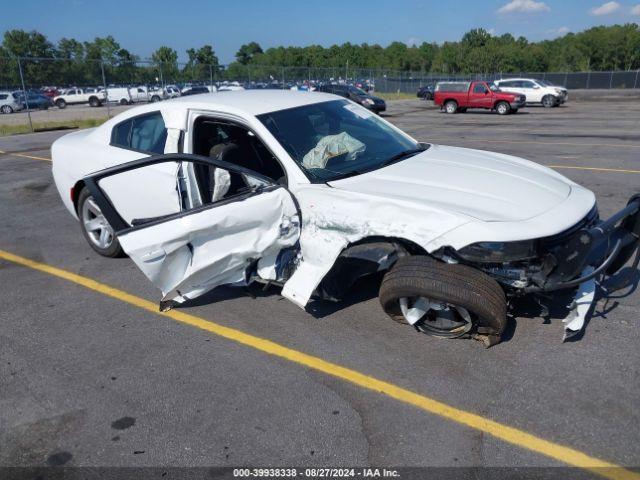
0;0;640;63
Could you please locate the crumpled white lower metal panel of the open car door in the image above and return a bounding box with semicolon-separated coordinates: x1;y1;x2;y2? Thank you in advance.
119;188;300;302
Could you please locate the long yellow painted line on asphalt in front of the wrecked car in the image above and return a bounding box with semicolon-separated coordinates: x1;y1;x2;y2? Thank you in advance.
0;250;640;480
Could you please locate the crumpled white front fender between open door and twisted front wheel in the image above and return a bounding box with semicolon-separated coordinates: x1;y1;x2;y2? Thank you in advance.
282;185;468;307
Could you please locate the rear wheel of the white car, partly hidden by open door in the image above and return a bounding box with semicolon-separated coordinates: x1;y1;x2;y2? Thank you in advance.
78;187;124;258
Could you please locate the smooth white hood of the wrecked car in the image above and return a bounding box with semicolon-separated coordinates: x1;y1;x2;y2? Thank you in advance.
329;145;571;222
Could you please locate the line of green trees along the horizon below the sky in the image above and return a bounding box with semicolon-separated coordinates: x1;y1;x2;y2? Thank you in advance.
0;23;640;86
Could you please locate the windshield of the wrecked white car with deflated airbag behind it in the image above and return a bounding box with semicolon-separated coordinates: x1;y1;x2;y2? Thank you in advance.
258;100;425;183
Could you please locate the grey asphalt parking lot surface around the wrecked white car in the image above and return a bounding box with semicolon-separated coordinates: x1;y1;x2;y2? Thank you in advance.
0;100;640;478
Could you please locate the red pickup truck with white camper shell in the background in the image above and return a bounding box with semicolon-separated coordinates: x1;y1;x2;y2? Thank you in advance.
433;82;527;115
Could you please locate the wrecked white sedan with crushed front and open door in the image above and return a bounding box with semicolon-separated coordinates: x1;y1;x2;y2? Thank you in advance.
52;91;640;345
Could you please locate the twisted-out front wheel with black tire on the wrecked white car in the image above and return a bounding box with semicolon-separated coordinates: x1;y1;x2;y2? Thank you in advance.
380;255;507;340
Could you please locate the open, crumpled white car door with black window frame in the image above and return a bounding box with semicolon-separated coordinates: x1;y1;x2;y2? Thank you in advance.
84;154;300;309
